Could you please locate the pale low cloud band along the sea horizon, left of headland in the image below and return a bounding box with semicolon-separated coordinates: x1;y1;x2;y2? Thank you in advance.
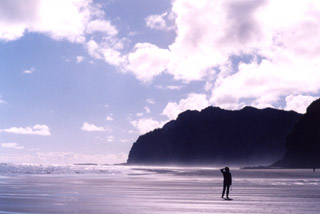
0;152;128;164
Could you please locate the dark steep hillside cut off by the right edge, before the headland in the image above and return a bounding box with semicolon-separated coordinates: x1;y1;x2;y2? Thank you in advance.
273;99;320;168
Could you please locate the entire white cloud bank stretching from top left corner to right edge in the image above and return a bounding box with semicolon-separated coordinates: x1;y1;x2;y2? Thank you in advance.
0;0;320;118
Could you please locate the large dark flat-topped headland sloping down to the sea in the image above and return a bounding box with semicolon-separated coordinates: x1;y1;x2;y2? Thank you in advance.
127;107;302;165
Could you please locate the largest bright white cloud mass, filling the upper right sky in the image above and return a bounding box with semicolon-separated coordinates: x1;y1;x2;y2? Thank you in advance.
125;0;320;109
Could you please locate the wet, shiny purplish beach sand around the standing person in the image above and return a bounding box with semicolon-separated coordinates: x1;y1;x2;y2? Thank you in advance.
0;166;320;214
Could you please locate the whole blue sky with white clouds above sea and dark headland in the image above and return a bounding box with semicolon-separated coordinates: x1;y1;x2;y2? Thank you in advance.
0;0;320;164
